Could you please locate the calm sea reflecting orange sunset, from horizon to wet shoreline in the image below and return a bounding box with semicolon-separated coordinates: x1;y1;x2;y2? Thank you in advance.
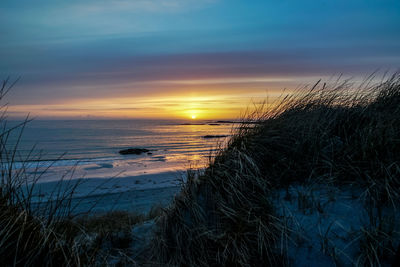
8;120;233;183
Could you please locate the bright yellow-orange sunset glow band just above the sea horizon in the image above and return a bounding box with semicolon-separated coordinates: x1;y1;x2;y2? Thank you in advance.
5;85;290;120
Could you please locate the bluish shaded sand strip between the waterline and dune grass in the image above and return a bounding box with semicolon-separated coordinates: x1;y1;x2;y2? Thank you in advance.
32;171;185;214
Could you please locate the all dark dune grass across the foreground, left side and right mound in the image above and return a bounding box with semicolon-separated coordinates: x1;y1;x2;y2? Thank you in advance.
0;75;400;266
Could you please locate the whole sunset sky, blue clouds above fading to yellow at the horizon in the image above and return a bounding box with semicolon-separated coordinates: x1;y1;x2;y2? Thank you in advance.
0;0;400;119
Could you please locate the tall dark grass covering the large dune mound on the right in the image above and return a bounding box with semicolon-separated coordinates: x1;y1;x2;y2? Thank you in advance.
152;74;400;266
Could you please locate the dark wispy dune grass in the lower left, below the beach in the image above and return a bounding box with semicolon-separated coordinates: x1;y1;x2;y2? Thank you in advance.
0;79;160;266
